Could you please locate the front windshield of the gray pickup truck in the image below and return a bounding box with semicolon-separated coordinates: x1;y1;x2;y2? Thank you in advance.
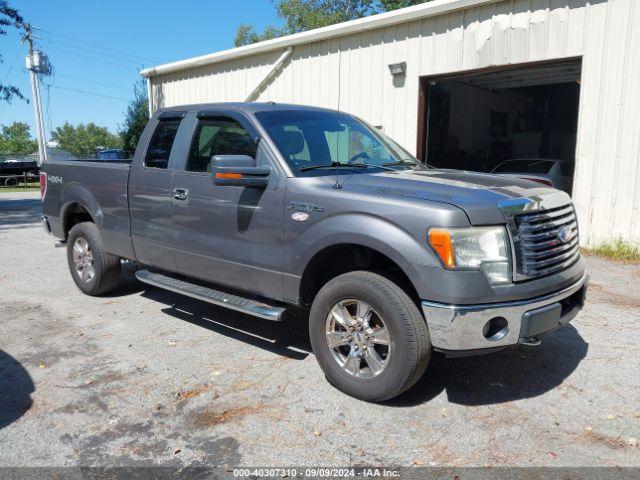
256;110;425;176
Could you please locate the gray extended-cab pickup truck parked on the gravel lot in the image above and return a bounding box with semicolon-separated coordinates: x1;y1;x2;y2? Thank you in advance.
42;103;587;401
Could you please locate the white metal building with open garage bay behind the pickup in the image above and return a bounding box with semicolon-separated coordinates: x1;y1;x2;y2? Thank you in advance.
142;0;640;245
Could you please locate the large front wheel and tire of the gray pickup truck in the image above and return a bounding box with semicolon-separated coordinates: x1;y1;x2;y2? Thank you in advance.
309;271;431;402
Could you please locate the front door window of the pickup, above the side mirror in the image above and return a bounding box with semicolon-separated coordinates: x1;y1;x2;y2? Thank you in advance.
186;117;257;172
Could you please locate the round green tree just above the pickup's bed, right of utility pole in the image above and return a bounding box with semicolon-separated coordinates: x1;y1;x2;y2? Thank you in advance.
51;122;122;157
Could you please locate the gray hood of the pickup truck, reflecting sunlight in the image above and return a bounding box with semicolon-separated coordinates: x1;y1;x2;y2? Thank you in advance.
343;169;569;225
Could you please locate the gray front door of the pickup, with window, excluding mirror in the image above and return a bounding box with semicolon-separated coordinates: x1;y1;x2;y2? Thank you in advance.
173;112;284;298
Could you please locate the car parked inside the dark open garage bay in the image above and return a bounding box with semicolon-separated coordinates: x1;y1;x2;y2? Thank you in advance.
491;158;574;195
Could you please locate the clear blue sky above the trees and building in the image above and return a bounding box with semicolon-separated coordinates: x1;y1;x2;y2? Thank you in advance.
0;0;279;139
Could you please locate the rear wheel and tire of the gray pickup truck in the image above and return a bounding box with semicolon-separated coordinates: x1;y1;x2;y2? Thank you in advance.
67;222;120;296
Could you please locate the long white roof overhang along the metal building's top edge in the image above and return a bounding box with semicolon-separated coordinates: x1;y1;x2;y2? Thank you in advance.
140;0;499;77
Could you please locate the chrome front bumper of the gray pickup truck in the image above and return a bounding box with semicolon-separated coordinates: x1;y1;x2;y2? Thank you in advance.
422;274;588;353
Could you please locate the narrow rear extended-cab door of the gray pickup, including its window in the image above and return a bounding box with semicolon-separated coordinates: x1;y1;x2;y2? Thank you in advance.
129;112;186;270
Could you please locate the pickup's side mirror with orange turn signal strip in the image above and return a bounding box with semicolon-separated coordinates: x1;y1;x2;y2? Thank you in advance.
211;155;271;187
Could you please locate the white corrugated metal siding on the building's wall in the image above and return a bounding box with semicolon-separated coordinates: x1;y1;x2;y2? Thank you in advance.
151;0;640;245
